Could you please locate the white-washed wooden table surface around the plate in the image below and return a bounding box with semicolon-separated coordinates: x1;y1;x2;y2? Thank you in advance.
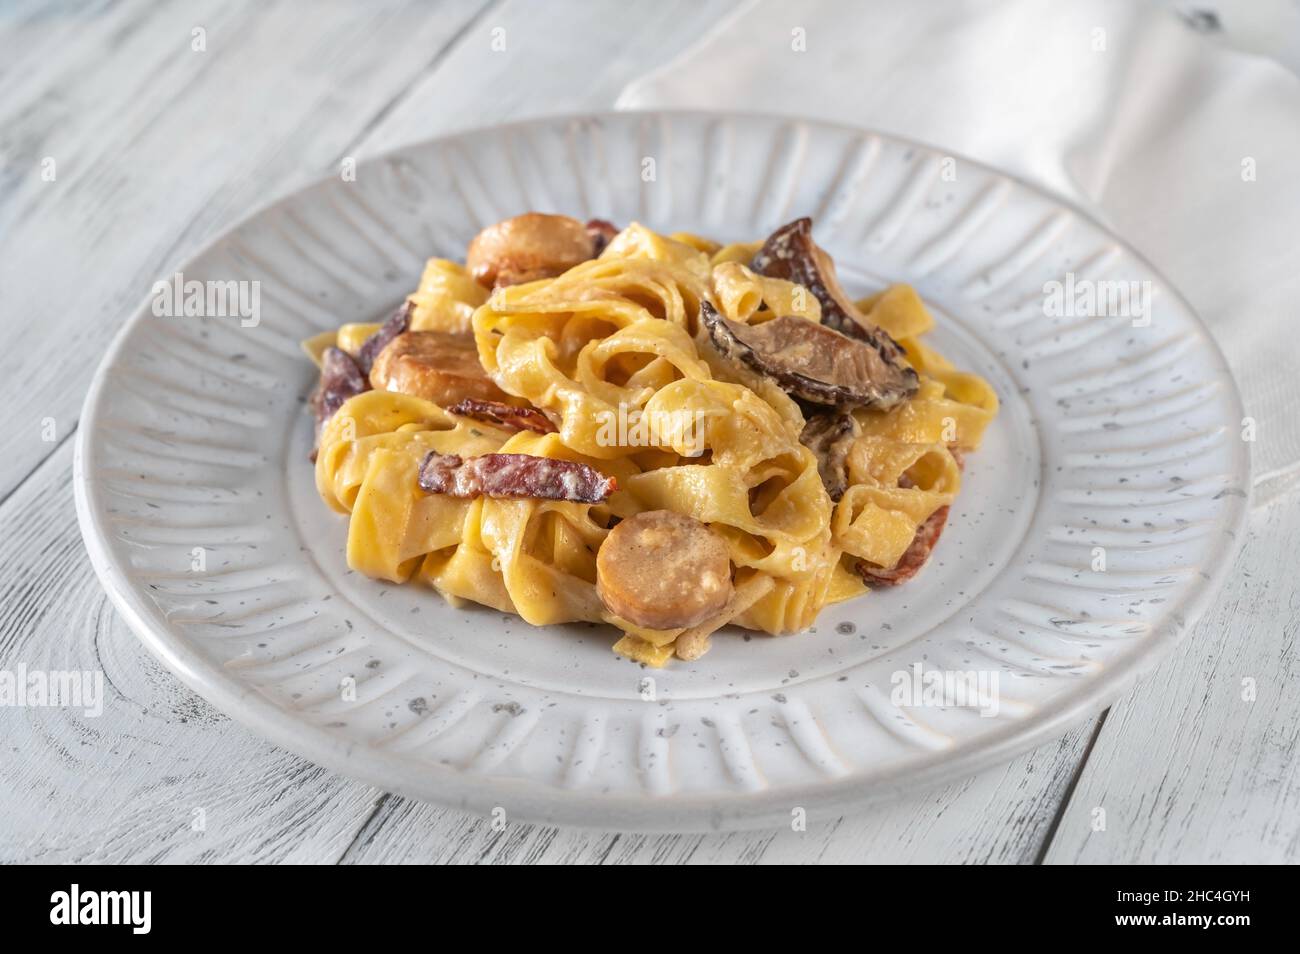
0;0;1300;863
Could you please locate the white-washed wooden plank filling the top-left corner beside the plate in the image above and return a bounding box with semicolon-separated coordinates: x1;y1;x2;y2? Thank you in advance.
0;0;486;500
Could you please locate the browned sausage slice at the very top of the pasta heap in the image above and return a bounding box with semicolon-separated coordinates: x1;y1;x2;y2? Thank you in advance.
465;212;595;289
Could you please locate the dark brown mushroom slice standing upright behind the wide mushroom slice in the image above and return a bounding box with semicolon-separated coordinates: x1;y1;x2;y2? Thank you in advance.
750;217;918;400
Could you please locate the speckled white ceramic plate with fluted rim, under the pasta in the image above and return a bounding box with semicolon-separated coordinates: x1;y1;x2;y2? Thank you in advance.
75;113;1249;829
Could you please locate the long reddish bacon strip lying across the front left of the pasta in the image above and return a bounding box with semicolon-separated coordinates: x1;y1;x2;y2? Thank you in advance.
420;451;619;503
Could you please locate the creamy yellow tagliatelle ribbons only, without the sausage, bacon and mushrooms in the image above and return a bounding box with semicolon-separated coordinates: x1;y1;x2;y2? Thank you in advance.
313;220;997;665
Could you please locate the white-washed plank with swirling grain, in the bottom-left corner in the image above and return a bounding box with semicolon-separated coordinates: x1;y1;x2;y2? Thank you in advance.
0;446;377;863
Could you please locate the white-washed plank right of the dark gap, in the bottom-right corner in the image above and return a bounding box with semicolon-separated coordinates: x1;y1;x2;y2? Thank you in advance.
1045;494;1300;864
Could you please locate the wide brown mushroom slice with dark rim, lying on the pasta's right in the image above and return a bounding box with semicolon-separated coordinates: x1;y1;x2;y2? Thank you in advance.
699;302;917;408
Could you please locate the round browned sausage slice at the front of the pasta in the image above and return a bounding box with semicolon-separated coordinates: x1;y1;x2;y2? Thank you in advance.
595;509;732;629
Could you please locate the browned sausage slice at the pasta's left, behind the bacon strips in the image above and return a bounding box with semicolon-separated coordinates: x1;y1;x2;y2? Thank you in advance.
371;331;510;407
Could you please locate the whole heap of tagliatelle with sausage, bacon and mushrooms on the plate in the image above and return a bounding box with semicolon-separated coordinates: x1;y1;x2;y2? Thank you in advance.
306;213;997;667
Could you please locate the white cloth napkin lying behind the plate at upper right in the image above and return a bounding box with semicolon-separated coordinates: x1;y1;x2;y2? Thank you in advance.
618;0;1300;504
